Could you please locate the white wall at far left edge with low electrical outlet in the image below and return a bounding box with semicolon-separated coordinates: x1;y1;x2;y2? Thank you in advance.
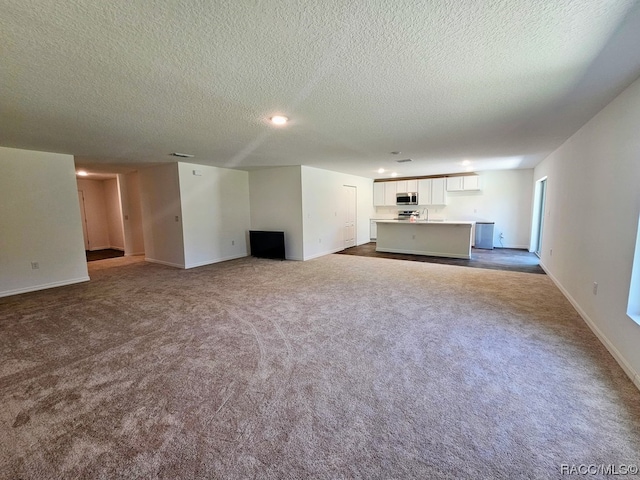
0;147;89;297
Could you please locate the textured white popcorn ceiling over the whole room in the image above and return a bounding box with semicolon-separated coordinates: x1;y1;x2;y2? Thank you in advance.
0;0;640;178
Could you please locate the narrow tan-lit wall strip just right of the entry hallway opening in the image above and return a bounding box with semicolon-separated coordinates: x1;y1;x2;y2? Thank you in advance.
118;172;144;255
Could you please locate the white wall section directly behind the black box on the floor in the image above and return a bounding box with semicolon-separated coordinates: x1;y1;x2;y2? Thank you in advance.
249;166;304;260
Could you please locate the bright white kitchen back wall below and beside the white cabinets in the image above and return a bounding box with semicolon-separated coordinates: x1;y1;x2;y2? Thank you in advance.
374;169;533;249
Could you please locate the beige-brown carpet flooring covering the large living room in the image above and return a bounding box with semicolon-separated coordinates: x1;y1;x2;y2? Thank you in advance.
0;255;640;479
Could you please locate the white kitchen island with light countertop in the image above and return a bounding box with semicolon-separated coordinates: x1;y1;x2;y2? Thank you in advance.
376;220;473;258
